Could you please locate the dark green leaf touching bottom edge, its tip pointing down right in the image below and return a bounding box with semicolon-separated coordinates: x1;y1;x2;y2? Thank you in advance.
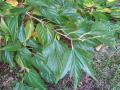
24;70;47;90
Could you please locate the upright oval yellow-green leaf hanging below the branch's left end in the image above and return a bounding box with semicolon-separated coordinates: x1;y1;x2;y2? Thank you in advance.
25;20;34;40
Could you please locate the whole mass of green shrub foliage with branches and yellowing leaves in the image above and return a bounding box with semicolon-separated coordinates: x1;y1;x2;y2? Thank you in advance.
0;0;120;90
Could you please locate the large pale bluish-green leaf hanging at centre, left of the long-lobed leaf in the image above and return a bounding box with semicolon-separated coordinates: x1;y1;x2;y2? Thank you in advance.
43;40;65;83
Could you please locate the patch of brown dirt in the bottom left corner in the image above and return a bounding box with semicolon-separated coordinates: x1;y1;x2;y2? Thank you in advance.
0;62;19;90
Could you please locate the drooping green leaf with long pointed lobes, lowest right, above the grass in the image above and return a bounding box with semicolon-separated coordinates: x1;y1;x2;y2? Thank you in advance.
65;48;95;90
